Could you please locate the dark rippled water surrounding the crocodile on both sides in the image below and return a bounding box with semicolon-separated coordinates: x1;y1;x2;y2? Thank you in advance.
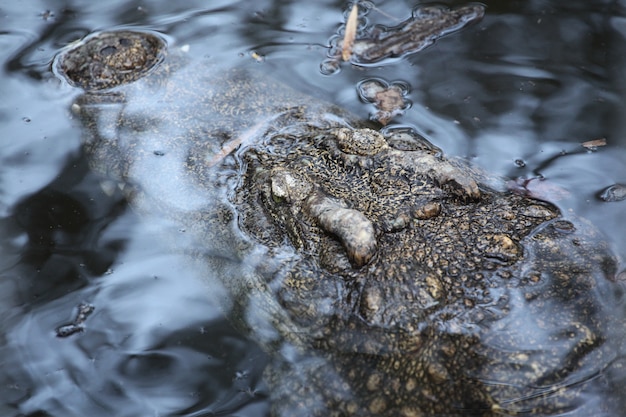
0;1;626;416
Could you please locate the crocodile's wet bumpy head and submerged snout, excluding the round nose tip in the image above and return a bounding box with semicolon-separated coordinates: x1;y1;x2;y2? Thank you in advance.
56;30;623;417
